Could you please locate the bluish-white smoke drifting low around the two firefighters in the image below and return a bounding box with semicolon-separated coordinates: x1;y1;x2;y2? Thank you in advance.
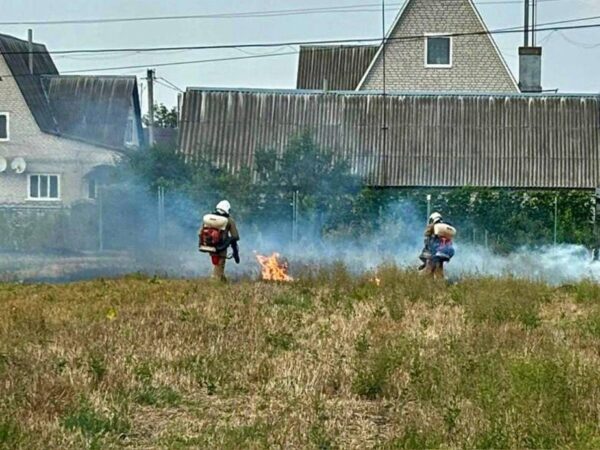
0;165;600;284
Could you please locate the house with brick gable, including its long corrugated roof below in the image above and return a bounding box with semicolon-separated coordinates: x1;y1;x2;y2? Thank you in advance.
179;0;600;189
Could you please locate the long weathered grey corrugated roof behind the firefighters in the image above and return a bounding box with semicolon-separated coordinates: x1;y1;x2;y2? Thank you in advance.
179;89;600;189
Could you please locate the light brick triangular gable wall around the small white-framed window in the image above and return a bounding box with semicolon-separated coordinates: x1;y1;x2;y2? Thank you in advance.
360;0;518;93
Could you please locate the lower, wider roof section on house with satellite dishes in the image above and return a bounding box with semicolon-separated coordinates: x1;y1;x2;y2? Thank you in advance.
43;75;142;149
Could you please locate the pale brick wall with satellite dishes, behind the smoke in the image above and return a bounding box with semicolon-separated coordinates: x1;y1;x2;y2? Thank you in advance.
0;55;119;208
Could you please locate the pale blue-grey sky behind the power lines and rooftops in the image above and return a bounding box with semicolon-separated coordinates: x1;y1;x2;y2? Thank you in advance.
0;0;600;108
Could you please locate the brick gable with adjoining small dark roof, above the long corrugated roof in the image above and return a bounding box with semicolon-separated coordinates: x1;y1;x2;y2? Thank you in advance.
296;0;519;93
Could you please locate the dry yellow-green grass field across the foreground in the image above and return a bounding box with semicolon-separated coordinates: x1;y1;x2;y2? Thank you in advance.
0;266;600;449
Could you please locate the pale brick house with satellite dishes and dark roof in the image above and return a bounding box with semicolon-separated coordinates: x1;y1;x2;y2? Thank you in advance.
0;35;144;251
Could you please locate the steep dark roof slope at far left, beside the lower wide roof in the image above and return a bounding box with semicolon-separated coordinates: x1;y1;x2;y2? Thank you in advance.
0;34;58;134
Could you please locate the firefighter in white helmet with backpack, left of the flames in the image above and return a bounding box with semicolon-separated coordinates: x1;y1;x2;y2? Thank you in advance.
198;200;240;281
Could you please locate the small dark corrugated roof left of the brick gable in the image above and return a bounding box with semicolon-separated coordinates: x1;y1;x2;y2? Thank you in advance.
296;45;378;91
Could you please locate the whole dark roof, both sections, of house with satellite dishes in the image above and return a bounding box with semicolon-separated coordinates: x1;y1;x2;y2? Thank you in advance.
0;34;143;150
